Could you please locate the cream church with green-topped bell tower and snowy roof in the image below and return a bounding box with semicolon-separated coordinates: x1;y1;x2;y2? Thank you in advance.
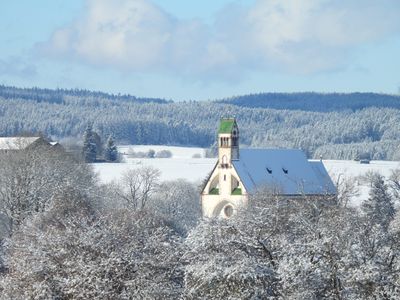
201;118;336;218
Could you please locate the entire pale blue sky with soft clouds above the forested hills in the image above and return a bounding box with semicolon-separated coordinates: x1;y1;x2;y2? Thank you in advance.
0;0;400;101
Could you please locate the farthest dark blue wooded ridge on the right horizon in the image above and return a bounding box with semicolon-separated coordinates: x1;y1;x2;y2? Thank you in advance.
217;92;400;112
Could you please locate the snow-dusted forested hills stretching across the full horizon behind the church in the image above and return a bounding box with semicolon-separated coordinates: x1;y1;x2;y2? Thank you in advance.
0;86;400;160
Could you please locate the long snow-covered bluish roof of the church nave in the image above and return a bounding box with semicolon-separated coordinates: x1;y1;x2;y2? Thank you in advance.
232;149;336;195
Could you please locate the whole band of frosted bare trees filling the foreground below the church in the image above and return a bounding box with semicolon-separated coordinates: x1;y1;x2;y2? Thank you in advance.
0;148;400;299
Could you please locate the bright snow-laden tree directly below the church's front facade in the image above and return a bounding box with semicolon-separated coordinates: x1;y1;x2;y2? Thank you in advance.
184;219;279;299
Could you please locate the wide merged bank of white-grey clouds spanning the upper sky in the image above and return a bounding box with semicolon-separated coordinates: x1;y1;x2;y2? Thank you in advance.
42;0;400;78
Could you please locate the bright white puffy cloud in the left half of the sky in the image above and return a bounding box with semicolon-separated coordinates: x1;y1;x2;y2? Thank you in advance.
45;0;173;69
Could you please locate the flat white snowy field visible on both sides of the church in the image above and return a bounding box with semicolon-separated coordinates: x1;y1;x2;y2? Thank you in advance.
93;145;400;205
